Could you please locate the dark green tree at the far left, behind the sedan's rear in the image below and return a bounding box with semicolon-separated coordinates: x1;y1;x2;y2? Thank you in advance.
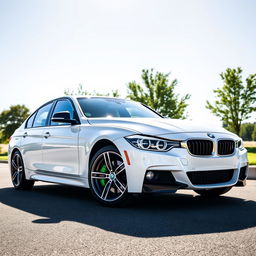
0;105;29;142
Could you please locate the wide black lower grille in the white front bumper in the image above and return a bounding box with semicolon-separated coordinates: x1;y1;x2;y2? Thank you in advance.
187;169;234;185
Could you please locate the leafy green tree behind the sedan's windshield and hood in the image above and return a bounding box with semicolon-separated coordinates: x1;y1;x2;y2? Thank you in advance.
128;69;190;119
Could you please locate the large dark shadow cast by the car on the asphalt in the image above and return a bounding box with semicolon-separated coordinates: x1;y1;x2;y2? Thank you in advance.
0;185;256;237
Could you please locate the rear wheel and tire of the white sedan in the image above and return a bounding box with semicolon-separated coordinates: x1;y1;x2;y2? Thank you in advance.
11;151;35;190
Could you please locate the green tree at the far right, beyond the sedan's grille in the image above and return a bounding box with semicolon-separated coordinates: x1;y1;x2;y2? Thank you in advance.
206;68;256;135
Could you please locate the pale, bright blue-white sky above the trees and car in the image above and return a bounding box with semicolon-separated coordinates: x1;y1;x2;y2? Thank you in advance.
0;0;256;123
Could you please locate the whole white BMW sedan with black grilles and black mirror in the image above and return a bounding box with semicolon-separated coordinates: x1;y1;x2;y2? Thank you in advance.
9;97;248;205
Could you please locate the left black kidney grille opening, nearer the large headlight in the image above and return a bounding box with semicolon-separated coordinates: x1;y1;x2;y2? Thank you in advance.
187;140;213;156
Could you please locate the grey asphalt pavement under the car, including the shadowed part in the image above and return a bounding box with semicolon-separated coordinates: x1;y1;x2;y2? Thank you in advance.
0;164;256;256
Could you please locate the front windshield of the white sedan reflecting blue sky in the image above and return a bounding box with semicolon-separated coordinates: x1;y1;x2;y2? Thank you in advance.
77;98;161;118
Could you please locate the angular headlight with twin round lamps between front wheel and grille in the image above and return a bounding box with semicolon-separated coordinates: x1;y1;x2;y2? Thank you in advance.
125;135;180;151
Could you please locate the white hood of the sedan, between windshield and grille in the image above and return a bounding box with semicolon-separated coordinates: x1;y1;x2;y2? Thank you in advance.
88;118;231;135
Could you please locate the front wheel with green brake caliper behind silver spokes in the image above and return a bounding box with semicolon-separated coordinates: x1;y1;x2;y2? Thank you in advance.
88;146;130;206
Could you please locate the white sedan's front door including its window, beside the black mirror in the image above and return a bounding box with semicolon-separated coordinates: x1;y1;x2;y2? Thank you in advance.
42;98;80;175
